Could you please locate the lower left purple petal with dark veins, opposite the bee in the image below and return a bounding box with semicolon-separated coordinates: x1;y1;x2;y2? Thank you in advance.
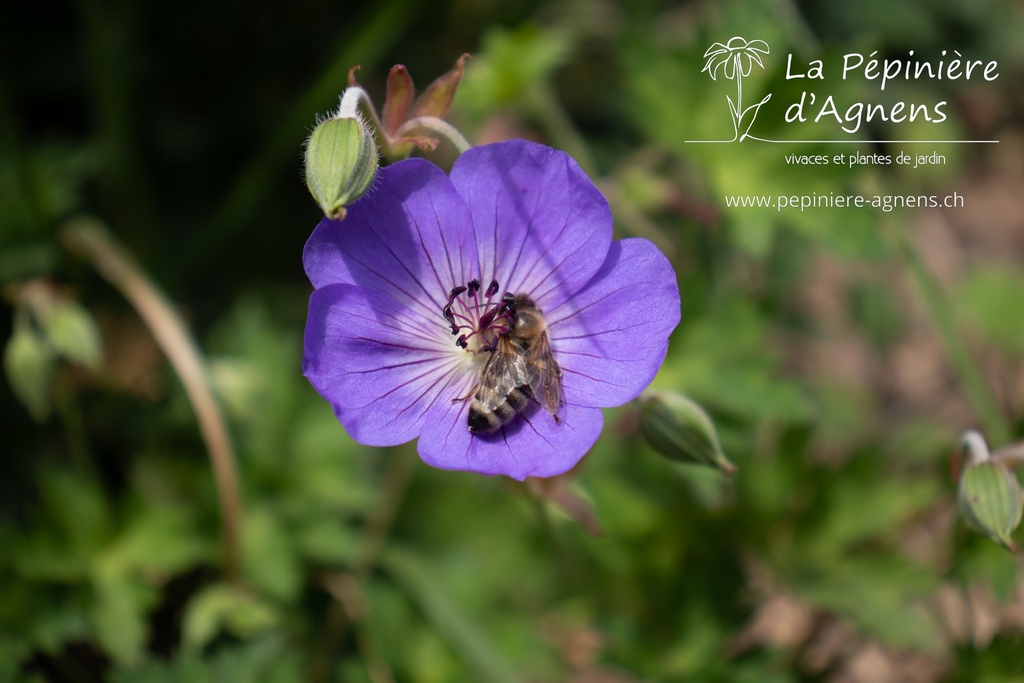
302;285;472;445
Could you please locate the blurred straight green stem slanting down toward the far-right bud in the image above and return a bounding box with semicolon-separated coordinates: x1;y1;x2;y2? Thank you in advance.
887;220;1010;443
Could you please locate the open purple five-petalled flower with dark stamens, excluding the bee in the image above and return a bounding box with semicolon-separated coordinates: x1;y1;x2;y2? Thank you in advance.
302;140;679;479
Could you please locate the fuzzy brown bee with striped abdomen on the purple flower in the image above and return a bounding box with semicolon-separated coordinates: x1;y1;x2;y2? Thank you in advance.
468;294;562;434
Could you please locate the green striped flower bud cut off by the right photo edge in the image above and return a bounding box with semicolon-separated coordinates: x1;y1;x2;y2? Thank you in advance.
958;460;1024;552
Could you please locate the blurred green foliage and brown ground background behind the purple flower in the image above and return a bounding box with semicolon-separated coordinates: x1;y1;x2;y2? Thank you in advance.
0;0;1024;683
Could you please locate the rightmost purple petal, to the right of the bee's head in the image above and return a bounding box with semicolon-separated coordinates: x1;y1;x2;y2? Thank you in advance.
547;239;679;408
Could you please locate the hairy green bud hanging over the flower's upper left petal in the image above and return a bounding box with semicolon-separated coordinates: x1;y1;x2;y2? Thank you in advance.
306;116;378;220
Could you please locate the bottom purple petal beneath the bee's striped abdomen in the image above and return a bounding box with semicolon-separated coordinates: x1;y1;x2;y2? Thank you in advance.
419;389;604;481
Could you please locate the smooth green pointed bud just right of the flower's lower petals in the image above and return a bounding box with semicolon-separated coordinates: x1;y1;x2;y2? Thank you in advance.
640;391;736;474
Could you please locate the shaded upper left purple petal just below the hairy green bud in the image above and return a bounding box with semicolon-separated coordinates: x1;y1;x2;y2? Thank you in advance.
302;159;476;317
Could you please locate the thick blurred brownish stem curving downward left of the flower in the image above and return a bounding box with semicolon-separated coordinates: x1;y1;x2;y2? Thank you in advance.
60;221;242;580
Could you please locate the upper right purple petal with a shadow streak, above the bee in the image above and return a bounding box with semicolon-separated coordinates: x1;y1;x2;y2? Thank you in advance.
452;140;611;308
